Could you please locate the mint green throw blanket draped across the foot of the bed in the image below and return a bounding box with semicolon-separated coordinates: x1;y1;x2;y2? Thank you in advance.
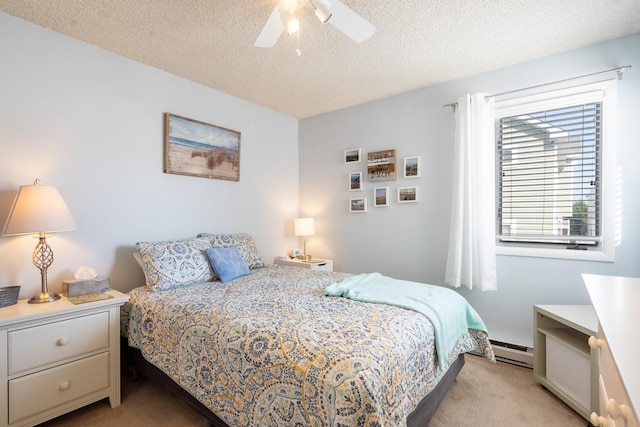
324;273;487;369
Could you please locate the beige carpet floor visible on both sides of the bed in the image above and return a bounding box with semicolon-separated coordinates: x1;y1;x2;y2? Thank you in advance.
42;356;587;427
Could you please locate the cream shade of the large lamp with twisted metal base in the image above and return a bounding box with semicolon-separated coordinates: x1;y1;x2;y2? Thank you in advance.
2;185;78;236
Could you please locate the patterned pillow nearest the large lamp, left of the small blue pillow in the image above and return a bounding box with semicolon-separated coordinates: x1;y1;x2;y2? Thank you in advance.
136;238;216;291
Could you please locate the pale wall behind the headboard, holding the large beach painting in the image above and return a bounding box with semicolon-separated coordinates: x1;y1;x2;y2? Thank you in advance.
0;13;298;298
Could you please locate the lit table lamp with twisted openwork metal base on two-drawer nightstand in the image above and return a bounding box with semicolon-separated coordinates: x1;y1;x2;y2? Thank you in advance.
2;179;77;304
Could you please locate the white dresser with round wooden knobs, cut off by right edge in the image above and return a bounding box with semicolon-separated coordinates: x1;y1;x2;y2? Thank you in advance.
582;274;640;427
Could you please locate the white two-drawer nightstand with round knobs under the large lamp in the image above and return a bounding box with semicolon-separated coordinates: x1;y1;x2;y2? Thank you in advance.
0;290;129;426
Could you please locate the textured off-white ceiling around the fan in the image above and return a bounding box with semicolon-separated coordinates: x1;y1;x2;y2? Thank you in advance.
0;0;640;118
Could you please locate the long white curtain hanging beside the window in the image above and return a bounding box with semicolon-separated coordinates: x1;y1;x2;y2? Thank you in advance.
445;93;497;291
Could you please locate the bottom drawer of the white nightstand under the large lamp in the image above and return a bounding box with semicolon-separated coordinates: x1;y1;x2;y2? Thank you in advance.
9;352;109;424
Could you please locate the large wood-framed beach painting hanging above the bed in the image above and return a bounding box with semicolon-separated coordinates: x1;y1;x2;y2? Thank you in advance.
164;113;240;181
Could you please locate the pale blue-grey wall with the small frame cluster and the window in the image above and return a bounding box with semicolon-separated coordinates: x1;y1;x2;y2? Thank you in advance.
300;34;640;346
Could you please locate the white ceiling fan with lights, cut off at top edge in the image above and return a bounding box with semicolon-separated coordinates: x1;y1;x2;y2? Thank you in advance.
253;0;376;47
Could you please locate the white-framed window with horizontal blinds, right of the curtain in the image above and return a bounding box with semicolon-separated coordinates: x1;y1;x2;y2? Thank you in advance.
495;82;615;261
